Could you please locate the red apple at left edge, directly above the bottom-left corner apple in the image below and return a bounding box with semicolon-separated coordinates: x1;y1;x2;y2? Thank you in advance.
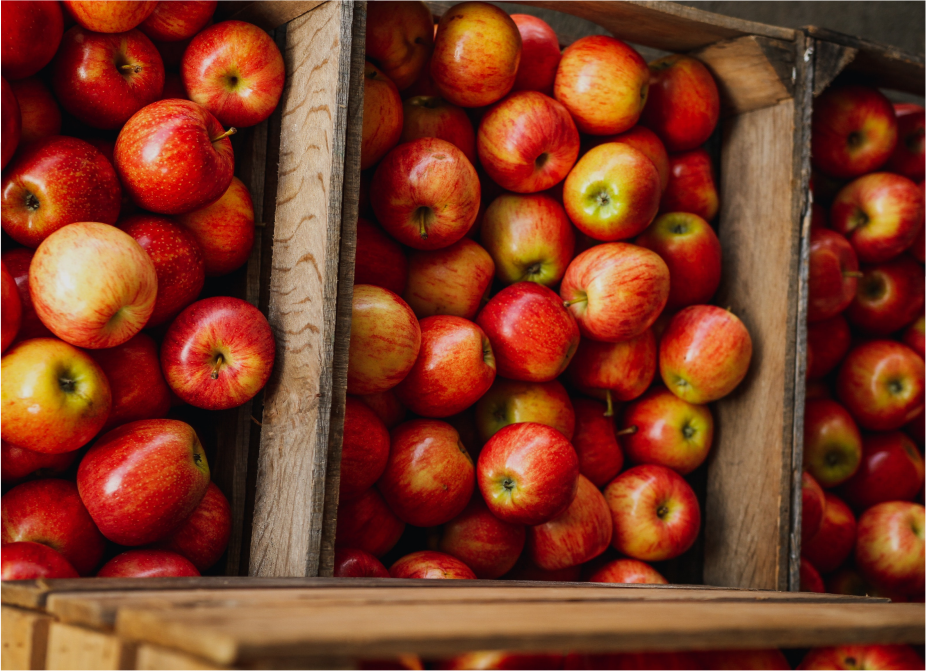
0;479;105;575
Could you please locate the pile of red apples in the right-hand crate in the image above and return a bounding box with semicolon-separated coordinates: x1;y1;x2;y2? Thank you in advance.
801;85;926;600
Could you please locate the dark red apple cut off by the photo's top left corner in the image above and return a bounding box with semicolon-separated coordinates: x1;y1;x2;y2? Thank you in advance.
0;0;64;80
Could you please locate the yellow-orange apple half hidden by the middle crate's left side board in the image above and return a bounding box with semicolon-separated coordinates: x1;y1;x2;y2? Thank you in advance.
347;284;421;395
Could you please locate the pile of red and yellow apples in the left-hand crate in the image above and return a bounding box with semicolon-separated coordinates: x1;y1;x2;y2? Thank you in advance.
0;0;284;580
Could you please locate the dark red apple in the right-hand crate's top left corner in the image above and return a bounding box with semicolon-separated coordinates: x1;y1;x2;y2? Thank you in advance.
810;85;897;179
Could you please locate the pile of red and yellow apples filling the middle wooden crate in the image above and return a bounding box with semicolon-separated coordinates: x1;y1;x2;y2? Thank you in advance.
335;0;752;582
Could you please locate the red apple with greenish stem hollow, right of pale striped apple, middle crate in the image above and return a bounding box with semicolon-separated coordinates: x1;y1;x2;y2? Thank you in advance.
634;212;724;310
